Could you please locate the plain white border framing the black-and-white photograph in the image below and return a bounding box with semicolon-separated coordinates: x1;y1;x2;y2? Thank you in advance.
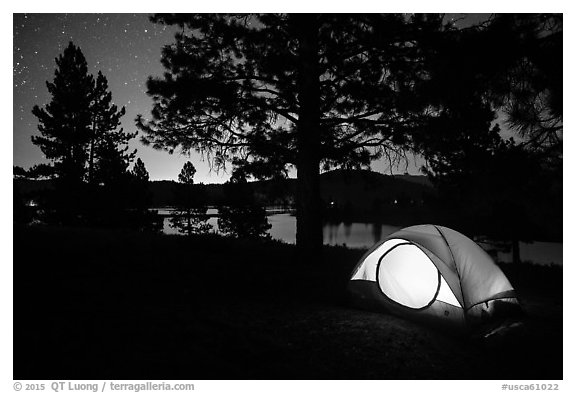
0;0;576;393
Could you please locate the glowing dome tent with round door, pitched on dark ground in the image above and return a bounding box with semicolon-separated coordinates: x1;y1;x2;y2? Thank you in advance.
349;225;519;327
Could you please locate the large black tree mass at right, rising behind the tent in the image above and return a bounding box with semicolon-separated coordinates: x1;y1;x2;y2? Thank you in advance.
413;14;562;260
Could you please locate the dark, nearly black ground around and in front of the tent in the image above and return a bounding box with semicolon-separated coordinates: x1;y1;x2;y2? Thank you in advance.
13;226;563;380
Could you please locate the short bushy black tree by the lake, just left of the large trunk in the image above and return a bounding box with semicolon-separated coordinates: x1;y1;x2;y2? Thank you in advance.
218;170;272;239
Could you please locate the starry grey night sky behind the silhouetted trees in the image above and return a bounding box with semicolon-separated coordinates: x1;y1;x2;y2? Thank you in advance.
13;14;486;183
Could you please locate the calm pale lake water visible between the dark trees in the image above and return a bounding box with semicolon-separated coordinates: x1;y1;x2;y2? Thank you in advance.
158;209;562;265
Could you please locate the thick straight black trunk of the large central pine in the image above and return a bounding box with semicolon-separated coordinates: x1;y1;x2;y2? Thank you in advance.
294;14;322;261
